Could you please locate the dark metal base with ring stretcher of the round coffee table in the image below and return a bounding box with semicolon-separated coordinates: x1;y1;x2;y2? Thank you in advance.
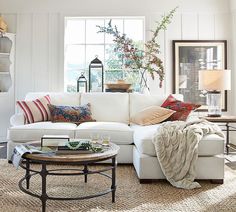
19;156;117;212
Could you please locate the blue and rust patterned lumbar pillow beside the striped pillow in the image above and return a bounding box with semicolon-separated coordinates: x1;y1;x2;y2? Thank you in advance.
48;103;95;124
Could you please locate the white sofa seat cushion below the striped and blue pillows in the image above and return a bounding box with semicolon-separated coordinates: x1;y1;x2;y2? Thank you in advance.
8;122;77;142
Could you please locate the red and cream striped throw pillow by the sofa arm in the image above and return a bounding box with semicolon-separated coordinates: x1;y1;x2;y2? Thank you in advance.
16;95;51;124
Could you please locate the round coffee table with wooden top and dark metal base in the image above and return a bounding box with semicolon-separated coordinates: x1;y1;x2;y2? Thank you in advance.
19;143;120;212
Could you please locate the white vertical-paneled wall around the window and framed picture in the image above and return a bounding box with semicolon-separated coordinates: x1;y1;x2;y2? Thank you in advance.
0;0;231;140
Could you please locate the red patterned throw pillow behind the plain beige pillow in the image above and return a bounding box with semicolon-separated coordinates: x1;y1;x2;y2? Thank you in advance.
161;95;201;121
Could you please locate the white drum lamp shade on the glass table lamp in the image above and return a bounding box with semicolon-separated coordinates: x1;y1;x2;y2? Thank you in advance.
198;70;231;91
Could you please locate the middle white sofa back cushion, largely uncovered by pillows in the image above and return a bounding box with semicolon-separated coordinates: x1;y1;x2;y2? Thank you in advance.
81;93;129;123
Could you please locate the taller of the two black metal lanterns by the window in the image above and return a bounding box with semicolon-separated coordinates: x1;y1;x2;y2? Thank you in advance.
89;56;104;92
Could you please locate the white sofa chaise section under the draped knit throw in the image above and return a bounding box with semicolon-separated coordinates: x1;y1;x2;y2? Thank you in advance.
131;125;224;182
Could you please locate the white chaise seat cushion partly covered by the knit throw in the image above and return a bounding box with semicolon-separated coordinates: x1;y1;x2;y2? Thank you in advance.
131;124;224;156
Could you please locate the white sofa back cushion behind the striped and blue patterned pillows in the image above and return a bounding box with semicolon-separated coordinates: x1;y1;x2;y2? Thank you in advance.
25;92;80;106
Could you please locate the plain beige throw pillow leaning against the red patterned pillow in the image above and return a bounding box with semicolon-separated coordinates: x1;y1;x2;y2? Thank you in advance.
131;106;175;126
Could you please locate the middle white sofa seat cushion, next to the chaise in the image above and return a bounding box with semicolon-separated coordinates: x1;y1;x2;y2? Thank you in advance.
75;122;133;144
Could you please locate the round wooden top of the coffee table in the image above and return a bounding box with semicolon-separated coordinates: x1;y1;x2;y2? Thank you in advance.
24;143;120;163
